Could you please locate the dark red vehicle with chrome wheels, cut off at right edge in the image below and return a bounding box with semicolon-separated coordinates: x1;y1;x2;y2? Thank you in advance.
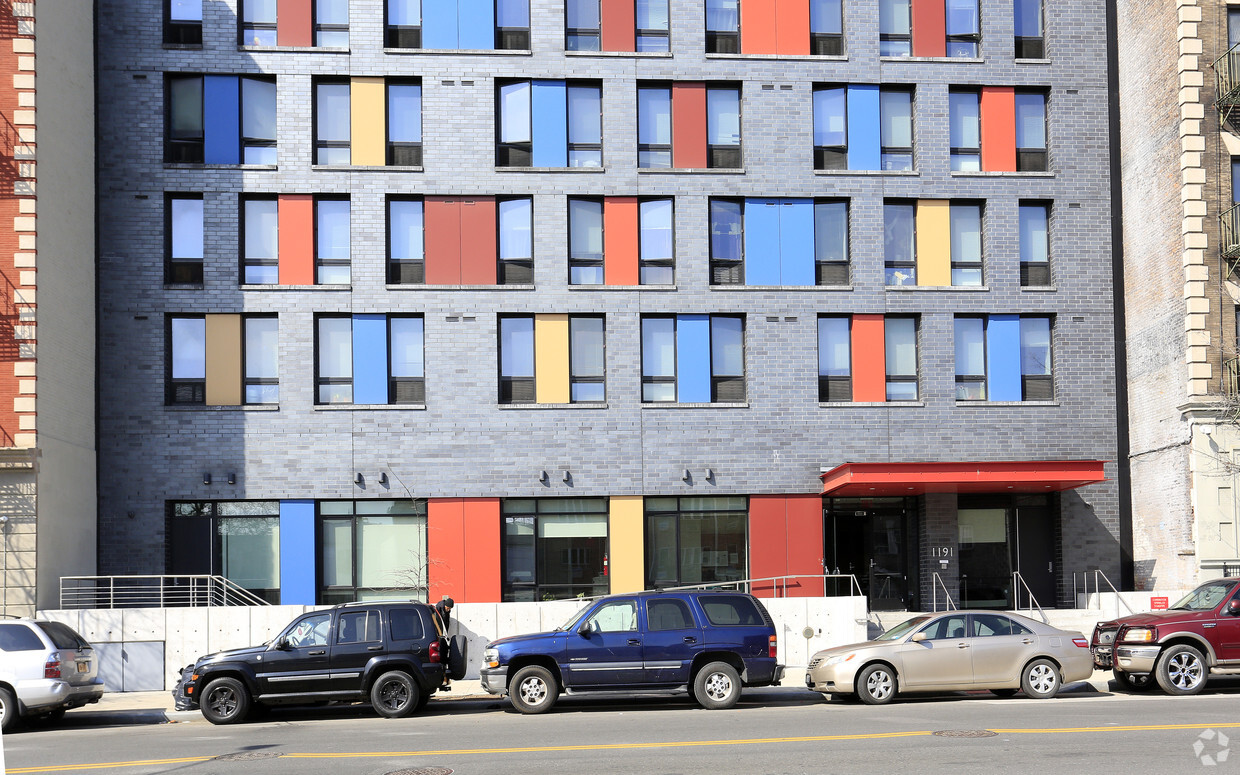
1091;578;1240;694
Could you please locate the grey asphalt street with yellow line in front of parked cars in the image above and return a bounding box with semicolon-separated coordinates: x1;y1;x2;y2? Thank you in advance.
2;678;1240;775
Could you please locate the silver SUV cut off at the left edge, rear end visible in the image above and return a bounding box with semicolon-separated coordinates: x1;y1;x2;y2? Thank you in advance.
0;619;103;732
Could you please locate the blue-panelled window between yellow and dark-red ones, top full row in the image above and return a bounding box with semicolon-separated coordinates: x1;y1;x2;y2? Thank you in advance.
496;81;603;167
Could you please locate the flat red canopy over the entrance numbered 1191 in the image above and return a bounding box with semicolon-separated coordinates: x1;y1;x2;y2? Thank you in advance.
821;460;1106;497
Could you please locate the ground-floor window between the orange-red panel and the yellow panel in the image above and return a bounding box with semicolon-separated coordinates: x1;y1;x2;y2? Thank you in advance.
500;498;610;603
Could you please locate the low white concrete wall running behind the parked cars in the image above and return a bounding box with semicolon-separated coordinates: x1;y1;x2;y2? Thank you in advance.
38;598;867;692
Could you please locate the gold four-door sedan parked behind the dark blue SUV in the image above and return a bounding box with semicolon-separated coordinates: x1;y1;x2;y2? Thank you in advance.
805;611;1094;706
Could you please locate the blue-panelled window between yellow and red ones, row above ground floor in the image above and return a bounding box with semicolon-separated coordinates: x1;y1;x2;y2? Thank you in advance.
641;315;745;403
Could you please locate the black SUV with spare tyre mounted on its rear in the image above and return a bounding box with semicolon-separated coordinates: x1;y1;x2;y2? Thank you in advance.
179;600;466;724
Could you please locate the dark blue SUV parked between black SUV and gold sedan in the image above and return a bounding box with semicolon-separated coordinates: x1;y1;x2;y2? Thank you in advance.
481;591;784;713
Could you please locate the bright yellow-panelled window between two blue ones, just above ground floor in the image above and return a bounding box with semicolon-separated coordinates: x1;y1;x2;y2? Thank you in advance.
500;315;606;404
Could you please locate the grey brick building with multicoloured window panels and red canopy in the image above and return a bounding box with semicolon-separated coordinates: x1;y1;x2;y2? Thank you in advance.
98;0;1126;609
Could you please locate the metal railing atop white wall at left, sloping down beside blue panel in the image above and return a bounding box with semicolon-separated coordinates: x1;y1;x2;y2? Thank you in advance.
61;575;270;609
